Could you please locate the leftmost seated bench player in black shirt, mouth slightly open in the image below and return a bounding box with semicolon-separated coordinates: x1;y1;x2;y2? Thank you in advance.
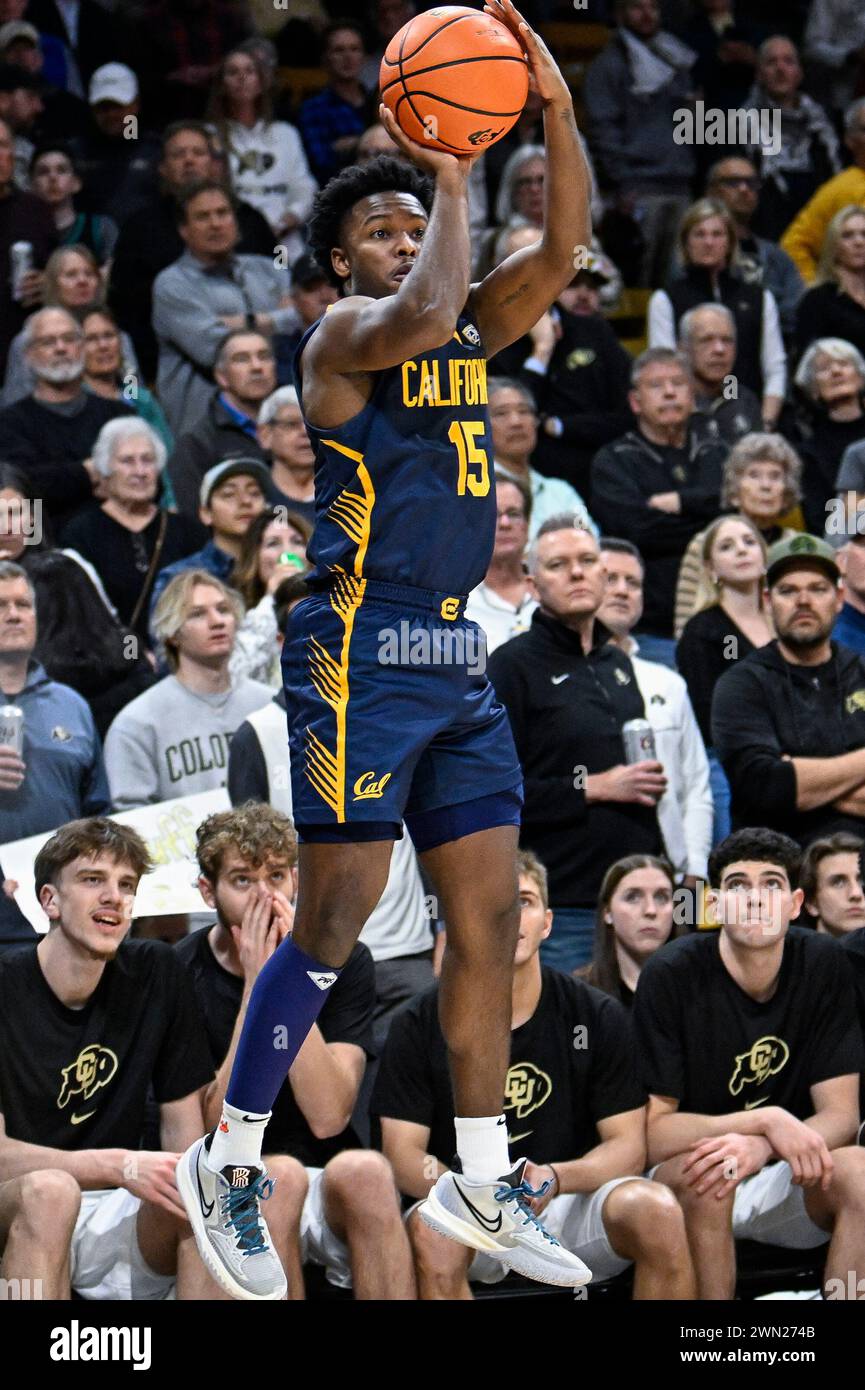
0;819;257;1300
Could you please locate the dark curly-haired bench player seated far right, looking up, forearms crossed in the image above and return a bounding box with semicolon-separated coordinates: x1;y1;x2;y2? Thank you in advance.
636;830;865;1298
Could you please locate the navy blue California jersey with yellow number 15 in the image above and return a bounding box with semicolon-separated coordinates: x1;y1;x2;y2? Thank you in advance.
295;314;495;595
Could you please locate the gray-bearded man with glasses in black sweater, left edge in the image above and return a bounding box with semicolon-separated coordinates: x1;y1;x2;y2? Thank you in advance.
0;309;135;530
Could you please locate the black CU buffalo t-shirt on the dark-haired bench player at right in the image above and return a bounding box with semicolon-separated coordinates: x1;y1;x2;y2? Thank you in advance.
634;927;865;1120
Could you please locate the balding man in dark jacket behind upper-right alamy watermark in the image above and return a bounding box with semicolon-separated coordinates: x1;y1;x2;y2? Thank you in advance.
744;35;841;240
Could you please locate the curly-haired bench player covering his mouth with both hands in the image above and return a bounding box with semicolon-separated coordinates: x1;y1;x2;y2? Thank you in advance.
177;803;414;1300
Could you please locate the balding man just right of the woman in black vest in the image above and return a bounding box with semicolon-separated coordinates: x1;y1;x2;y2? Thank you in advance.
679;304;762;445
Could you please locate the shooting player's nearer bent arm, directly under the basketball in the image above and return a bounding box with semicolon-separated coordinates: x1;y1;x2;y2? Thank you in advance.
305;116;477;374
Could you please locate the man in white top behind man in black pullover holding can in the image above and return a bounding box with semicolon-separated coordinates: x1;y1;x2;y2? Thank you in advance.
598;537;712;885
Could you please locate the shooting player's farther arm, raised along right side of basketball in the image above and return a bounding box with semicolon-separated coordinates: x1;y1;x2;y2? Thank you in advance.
471;0;591;357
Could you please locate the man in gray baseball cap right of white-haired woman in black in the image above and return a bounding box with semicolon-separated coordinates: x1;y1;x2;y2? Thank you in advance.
150;457;271;616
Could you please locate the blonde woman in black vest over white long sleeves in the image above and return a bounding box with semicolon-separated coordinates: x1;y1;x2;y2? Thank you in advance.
648;197;787;430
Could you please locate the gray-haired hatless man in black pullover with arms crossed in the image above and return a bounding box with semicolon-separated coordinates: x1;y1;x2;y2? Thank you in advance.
591;348;729;666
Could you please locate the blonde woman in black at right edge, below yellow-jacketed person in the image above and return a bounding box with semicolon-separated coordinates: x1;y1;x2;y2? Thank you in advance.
795;203;865;354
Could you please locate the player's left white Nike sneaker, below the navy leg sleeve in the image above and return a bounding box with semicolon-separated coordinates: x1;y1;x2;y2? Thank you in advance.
175;1138;288;1300
